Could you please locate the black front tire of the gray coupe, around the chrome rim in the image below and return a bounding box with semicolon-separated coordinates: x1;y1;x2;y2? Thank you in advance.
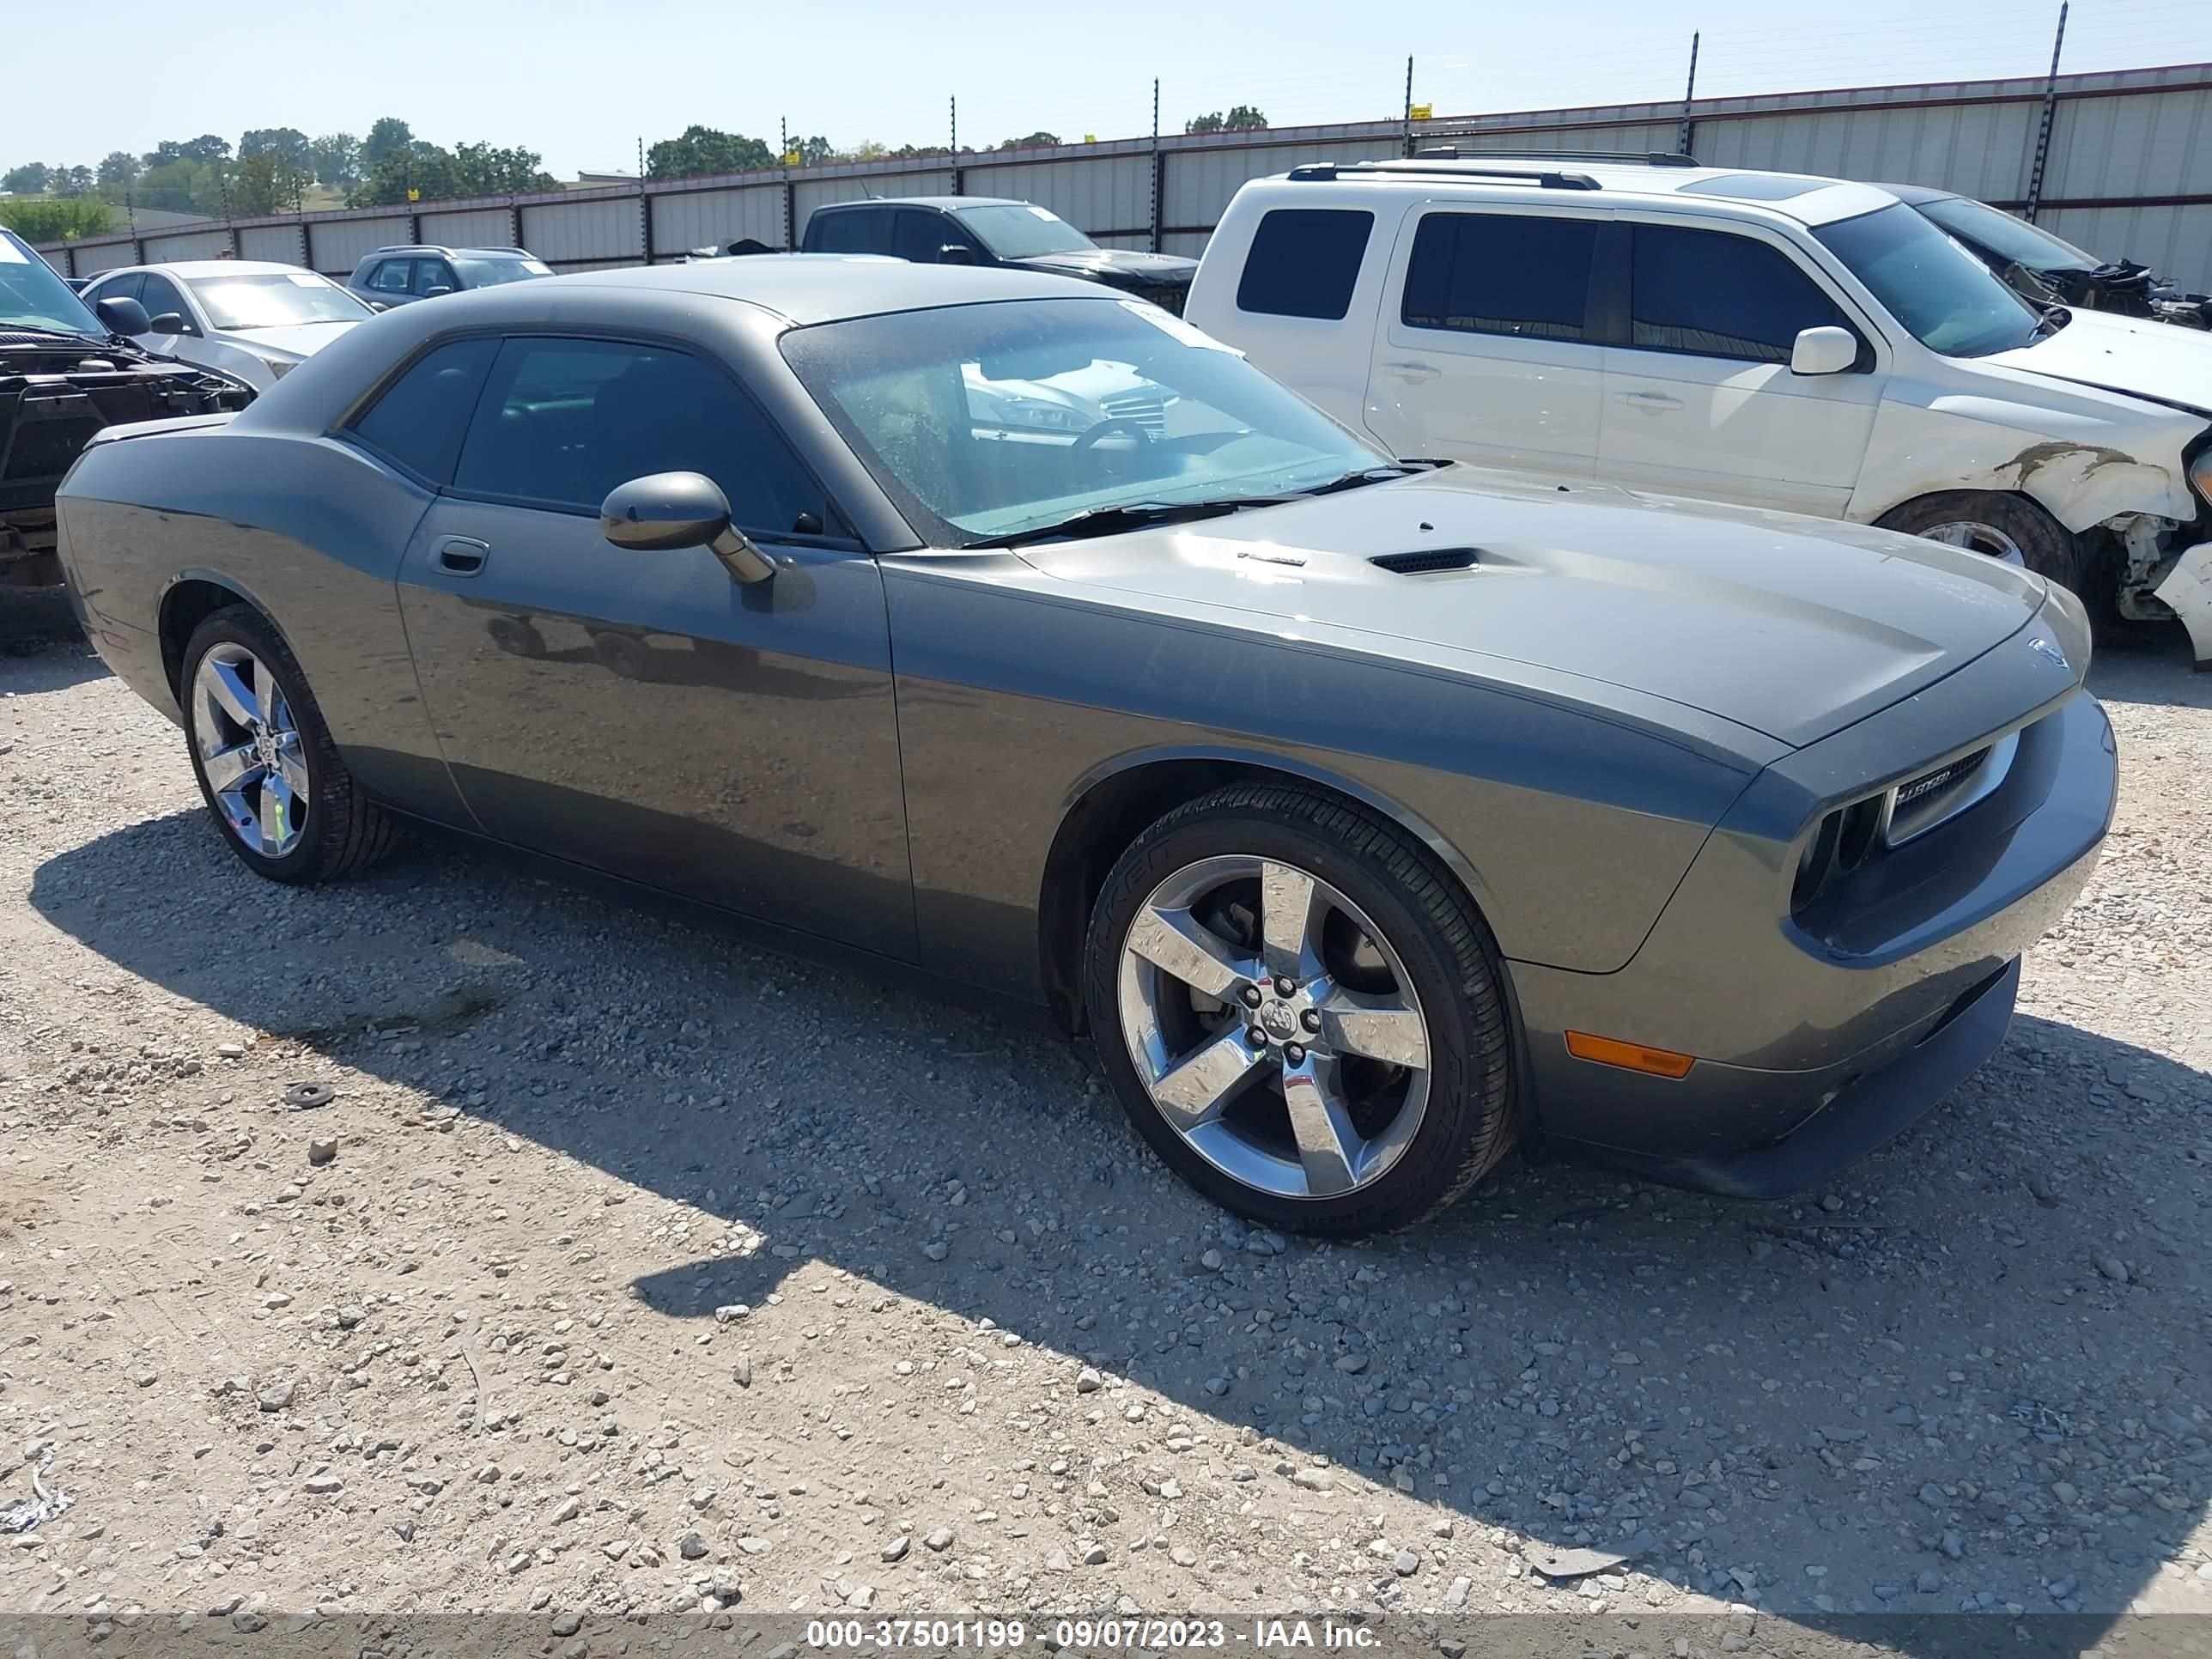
1084;783;1516;1239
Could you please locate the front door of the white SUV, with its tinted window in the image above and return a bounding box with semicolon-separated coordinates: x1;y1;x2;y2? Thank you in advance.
1597;222;1887;518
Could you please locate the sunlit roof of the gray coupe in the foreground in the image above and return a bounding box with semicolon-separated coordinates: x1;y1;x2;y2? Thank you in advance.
553;254;1121;325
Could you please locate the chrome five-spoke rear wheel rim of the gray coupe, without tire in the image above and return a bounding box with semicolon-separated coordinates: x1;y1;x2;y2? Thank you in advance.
191;641;312;858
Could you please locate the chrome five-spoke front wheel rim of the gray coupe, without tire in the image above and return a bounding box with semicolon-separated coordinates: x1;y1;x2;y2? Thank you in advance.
1117;856;1429;1199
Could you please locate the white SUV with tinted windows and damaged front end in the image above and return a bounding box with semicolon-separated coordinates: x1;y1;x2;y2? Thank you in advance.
1186;153;2212;665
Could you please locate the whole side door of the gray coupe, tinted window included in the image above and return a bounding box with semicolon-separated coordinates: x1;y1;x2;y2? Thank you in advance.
400;337;914;957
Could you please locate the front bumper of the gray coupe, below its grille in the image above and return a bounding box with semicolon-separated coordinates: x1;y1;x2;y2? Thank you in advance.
1509;671;2119;1197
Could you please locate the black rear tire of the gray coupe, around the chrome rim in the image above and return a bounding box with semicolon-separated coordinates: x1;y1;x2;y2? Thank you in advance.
181;604;398;884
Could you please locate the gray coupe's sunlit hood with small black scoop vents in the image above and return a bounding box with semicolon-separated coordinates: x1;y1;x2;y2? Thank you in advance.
1022;469;2044;748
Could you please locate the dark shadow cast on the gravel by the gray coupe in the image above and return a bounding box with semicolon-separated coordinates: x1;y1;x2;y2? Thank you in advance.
31;814;2212;1655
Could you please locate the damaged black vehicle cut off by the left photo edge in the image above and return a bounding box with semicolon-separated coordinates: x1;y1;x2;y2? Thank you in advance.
0;230;254;586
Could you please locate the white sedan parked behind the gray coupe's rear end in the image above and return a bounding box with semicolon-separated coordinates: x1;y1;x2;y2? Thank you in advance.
82;258;376;392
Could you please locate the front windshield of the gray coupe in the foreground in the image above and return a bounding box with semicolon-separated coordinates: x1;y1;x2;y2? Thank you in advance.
783;299;1389;546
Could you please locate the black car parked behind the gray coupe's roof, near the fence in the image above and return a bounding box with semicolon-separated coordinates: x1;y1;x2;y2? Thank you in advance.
801;197;1199;314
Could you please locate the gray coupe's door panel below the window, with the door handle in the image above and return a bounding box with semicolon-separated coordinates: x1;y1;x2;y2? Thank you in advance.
400;498;914;957
